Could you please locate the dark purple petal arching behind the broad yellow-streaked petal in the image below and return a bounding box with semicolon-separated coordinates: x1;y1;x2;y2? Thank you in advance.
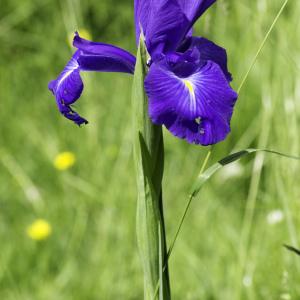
178;37;232;82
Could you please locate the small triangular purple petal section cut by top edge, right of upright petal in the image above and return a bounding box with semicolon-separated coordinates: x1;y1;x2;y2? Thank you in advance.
178;0;217;26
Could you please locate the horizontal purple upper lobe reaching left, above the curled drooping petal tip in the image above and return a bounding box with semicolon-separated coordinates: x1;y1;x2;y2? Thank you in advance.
73;33;136;74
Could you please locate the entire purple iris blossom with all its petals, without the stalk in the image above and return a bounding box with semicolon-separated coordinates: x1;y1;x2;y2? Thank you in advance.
49;0;237;145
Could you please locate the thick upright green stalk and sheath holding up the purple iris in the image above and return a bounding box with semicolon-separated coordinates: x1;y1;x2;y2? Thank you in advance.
132;42;170;300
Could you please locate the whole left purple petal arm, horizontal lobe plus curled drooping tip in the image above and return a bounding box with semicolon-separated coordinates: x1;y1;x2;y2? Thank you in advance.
48;34;135;125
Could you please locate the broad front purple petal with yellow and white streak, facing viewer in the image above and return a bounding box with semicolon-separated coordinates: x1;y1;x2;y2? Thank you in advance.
145;52;237;145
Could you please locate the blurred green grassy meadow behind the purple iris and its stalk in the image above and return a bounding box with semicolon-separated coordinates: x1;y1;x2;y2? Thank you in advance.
0;0;300;300
